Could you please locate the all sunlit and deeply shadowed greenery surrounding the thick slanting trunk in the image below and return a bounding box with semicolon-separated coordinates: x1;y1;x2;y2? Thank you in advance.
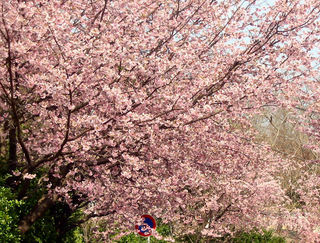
0;158;84;243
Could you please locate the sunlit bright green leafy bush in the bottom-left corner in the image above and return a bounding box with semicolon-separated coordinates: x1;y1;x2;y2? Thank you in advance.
0;186;23;243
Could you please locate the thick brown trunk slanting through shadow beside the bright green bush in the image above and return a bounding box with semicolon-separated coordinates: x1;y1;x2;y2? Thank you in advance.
18;195;56;234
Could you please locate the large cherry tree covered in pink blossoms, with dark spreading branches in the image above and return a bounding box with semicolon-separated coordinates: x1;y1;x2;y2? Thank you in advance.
0;0;320;240
